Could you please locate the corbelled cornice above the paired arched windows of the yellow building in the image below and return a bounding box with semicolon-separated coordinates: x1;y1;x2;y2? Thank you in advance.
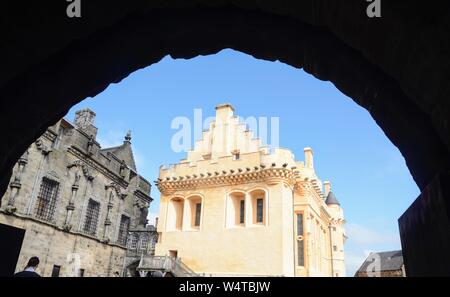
155;167;295;195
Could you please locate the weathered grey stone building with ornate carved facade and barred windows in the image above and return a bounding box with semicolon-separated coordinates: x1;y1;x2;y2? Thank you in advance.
0;109;152;276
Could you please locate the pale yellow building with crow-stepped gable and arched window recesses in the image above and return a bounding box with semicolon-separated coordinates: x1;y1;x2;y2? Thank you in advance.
155;104;345;276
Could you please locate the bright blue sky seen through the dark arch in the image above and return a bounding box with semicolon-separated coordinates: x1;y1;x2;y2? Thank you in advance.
67;50;419;276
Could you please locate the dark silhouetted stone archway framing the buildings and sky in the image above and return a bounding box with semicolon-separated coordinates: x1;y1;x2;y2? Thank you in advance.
0;0;450;272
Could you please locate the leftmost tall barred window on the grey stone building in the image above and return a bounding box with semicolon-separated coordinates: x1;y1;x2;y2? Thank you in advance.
36;177;59;221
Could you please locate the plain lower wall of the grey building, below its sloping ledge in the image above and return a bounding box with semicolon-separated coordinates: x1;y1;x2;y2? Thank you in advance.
0;213;126;277
